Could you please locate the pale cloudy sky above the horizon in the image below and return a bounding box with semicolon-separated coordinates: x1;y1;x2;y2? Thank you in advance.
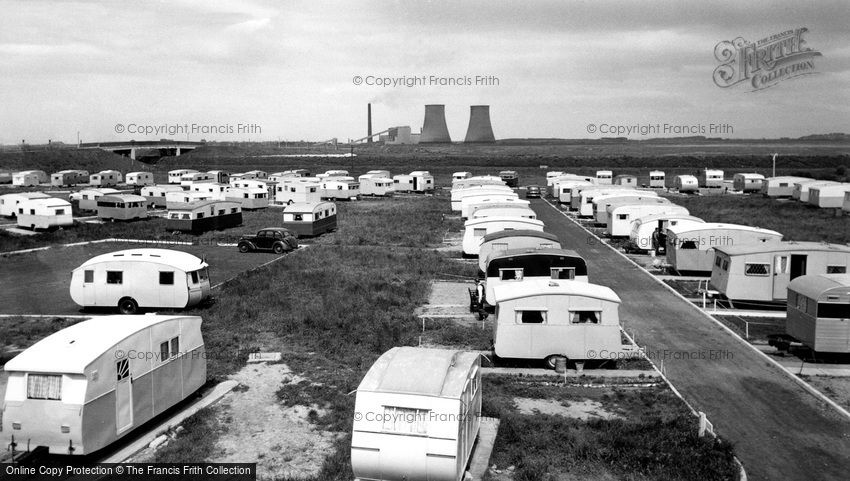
0;0;850;144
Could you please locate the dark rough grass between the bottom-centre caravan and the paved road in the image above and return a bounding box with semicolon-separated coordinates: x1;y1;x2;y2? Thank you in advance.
482;376;735;480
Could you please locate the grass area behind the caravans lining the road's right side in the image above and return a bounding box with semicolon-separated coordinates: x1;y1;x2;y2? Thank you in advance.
670;195;850;244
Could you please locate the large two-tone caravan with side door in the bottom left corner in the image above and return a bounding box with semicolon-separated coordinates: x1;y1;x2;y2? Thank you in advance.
0;315;207;452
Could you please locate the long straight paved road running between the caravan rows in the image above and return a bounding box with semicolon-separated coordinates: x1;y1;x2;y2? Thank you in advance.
531;200;850;480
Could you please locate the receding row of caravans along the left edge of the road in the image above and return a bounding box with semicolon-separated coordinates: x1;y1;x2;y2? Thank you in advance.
452;177;630;367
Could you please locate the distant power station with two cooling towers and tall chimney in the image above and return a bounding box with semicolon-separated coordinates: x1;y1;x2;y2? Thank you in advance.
352;104;496;144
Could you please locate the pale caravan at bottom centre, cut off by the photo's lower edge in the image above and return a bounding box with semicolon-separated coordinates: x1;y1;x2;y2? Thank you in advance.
351;347;481;481
